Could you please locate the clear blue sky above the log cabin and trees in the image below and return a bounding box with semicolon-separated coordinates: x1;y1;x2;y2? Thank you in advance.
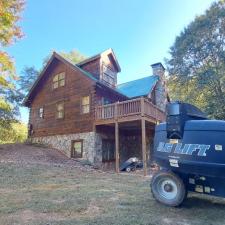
7;0;213;122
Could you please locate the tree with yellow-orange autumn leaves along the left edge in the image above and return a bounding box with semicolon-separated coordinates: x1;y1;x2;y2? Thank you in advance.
0;0;24;130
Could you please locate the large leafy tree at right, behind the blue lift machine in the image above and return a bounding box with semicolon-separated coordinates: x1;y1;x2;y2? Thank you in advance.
167;1;225;119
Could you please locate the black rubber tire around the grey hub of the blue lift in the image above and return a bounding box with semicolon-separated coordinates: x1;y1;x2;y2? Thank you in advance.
151;170;187;207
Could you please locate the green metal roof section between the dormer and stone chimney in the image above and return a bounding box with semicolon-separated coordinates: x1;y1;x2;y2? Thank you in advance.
116;75;159;98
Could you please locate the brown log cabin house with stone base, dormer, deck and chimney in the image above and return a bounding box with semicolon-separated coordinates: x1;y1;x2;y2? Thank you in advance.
24;49;167;173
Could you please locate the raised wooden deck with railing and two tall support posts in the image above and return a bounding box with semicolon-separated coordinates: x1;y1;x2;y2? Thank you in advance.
95;97;165;175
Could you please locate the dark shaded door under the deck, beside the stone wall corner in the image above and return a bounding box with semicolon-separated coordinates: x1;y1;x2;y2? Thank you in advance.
102;139;115;162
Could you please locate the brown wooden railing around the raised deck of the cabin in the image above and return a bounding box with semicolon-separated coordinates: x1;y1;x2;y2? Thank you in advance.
95;98;165;121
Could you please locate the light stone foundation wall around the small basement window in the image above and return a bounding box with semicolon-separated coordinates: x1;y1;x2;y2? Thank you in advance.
30;132;102;163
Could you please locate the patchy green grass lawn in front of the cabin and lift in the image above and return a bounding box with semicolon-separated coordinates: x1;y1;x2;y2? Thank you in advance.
0;163;225;225
